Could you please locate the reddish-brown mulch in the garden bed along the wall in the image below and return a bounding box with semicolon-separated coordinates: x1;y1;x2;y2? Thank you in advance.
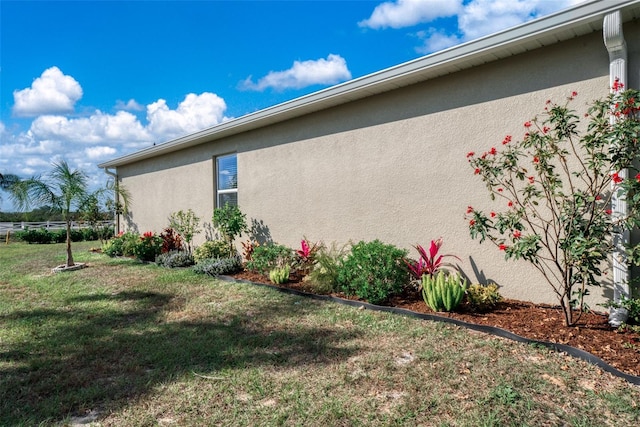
231;271;640;376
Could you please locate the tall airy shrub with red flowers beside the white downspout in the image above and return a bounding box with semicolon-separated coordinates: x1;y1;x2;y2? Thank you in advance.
466;87;640;325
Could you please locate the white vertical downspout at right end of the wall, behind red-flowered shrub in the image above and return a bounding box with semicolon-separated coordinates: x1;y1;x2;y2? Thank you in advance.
602;10;631;327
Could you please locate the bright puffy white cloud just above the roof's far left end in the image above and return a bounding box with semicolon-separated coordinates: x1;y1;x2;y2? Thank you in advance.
147;92;227;141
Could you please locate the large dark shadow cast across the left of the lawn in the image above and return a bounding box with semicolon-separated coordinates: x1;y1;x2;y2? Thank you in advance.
0;291;360;425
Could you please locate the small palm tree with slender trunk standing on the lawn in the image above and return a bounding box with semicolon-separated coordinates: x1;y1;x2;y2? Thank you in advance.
10;160;89;267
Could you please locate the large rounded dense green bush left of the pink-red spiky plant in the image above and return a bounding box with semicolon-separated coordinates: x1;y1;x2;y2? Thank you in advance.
338;240;410;304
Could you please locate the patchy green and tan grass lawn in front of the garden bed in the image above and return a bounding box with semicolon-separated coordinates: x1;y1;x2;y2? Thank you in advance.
0;243;640;426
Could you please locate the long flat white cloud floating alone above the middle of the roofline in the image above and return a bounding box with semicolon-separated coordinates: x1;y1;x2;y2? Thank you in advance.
240;54;351;91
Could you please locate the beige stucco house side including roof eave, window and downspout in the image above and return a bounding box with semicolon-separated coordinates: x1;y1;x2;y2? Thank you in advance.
99;0;640;307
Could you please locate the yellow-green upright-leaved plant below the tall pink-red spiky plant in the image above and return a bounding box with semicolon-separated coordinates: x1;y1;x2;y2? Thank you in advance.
422;271;467;311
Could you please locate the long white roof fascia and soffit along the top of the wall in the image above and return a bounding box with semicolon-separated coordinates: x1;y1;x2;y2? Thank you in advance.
98;0;640;168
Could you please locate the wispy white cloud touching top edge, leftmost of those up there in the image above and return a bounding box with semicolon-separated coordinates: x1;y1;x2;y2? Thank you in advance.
358;0;462;29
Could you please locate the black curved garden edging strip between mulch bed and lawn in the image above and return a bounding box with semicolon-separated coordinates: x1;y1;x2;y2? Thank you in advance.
217;275;640;386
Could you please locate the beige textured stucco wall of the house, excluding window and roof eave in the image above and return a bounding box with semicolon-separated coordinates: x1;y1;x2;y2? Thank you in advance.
118;19;640;306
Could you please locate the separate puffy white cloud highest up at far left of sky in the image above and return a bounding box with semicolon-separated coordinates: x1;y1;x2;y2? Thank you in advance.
13;67;82;116
